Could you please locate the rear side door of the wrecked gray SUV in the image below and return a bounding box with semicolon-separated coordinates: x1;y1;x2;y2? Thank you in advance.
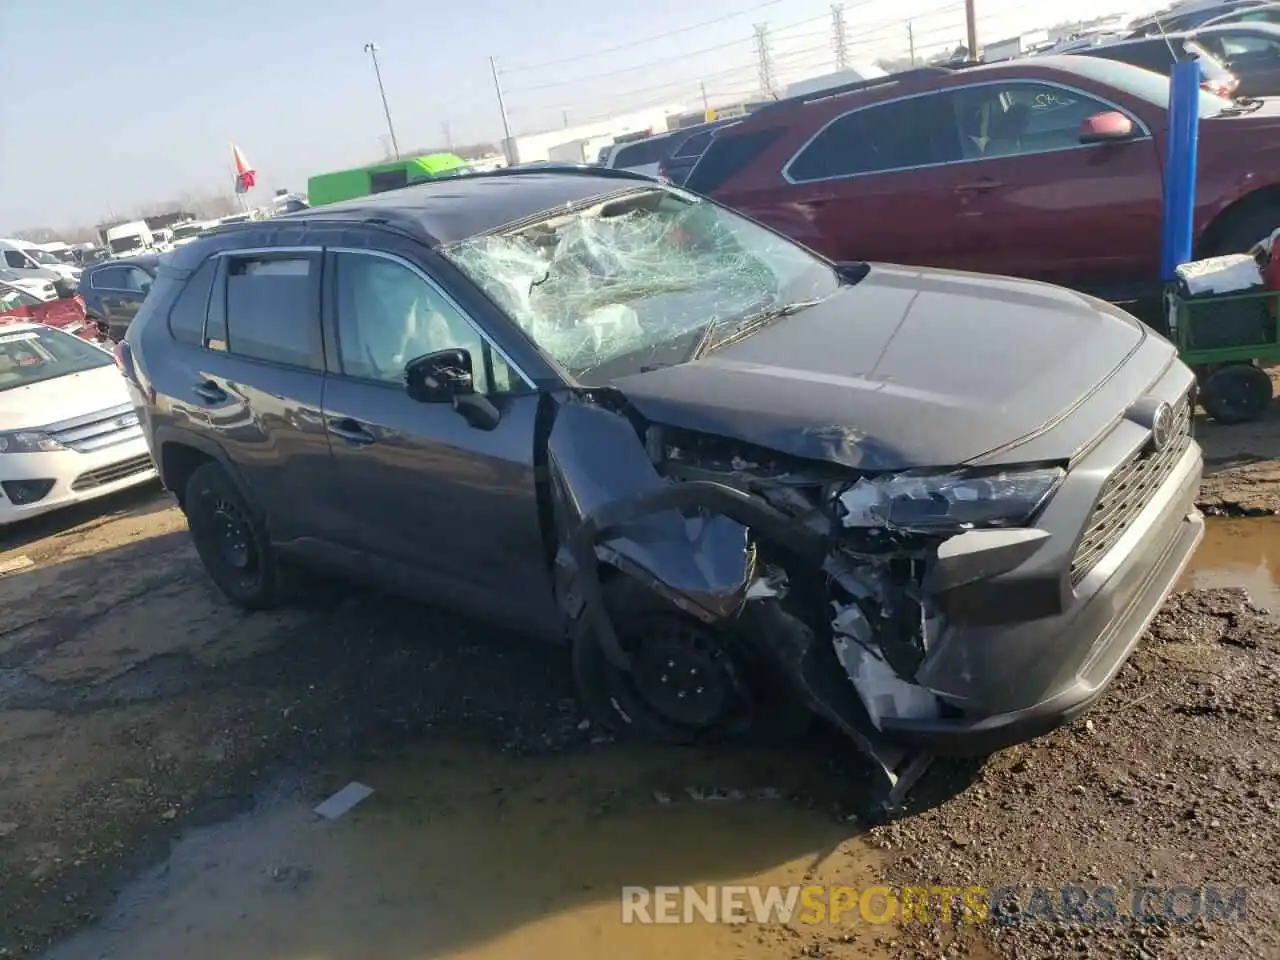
188;247;330;543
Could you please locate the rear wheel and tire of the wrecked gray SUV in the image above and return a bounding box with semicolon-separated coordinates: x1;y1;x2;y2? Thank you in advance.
183;463;280;611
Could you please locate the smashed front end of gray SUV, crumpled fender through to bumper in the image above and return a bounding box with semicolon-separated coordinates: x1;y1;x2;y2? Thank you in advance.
548;384;1203;781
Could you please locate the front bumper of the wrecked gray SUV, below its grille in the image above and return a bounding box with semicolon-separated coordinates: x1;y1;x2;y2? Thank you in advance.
881;443;1204;755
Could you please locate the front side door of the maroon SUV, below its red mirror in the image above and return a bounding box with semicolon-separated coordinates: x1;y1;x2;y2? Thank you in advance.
950;79;1161;296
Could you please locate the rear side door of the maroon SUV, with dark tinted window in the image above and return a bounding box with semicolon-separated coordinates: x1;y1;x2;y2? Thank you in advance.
762;93;963;266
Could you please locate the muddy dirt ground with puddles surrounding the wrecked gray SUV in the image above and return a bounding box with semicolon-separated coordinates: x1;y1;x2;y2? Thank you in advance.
0;391;1280;960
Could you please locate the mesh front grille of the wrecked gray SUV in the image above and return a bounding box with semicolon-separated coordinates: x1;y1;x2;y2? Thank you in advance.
1071;394;1192;586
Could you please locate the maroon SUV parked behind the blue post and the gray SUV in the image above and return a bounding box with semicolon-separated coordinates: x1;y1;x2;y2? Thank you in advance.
686;56;1280;300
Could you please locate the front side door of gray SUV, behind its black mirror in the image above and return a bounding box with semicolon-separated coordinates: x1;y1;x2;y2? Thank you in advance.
324;248;561;627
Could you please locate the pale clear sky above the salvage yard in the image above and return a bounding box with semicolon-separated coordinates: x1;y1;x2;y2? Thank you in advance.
0;0;1149;236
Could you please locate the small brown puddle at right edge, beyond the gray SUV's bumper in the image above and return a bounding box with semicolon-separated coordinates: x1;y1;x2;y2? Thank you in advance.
1179;517;1280;613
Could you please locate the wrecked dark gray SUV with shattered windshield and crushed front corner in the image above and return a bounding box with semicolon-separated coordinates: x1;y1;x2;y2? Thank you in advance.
118;168;1203;803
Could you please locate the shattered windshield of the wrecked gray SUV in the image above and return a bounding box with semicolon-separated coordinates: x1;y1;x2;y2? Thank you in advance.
443;187;840;383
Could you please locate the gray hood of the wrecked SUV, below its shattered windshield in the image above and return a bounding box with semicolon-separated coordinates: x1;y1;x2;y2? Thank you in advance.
613;265;1147;470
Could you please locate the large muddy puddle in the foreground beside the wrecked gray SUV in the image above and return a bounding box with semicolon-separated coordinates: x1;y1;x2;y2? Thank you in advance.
46;744;892;960
